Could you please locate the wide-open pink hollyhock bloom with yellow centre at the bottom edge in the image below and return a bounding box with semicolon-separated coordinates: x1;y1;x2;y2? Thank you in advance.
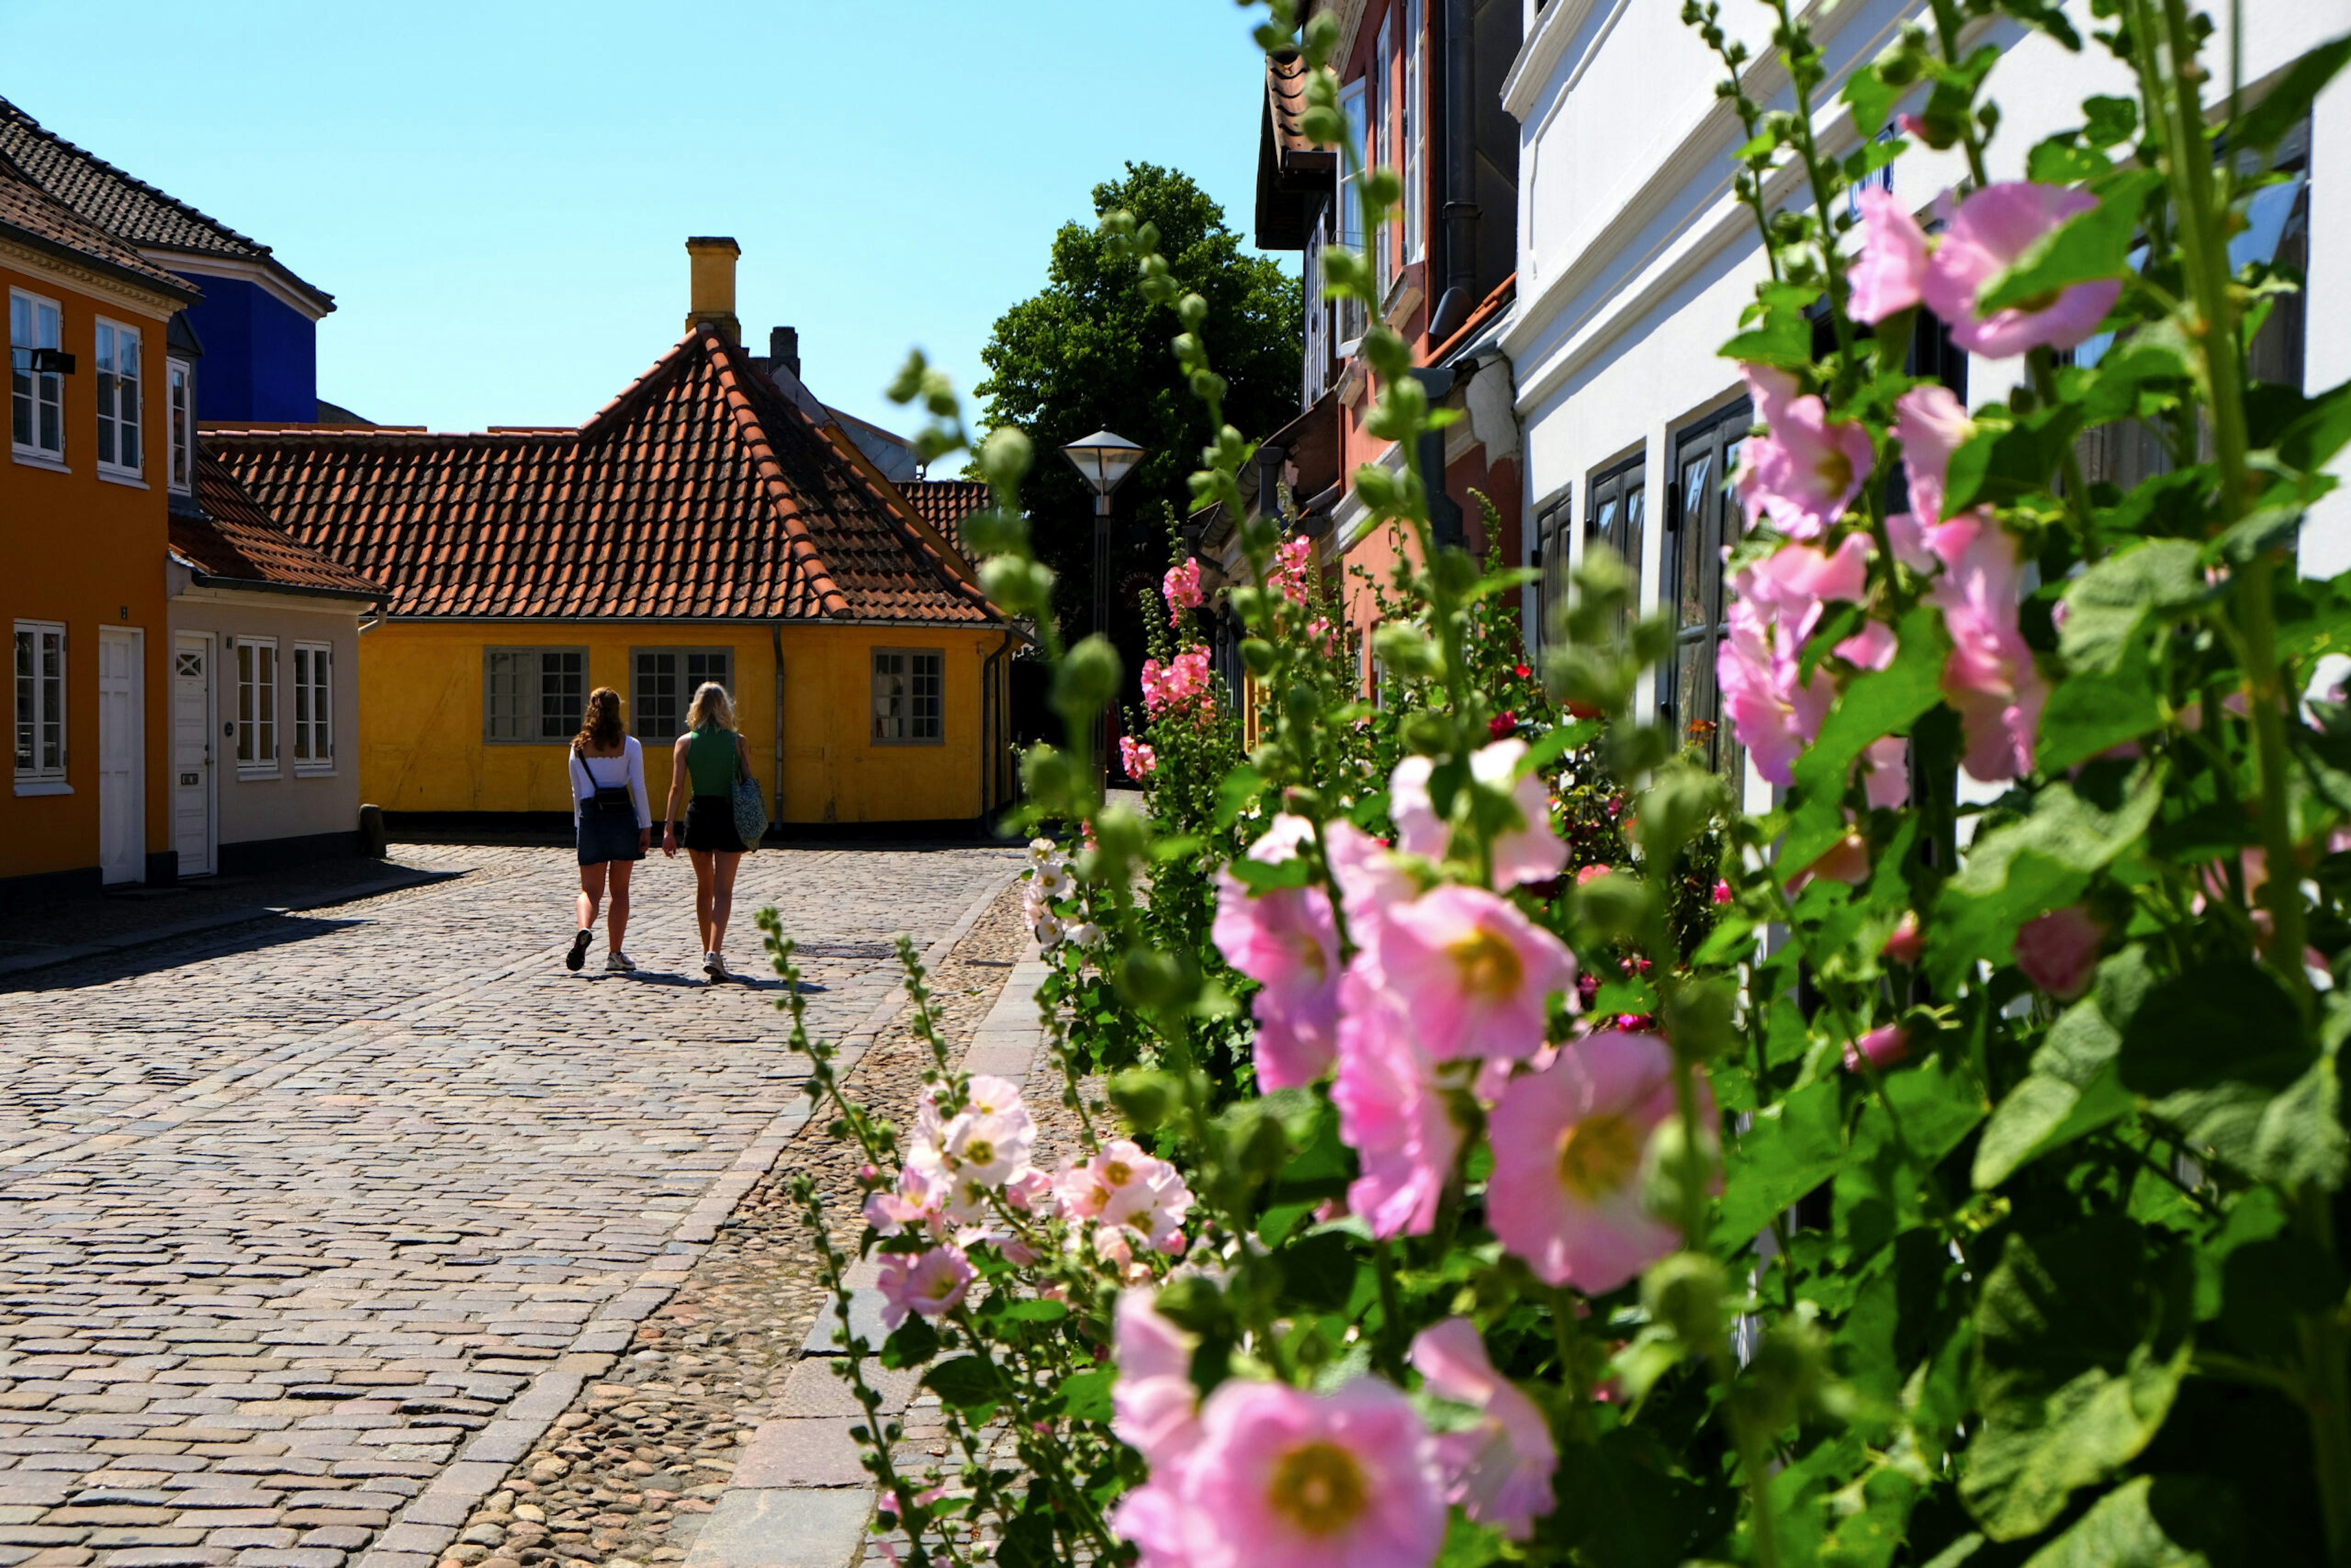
1142;1378;1446;1568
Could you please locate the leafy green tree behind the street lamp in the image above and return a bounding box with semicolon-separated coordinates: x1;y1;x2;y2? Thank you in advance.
976;162;1302;667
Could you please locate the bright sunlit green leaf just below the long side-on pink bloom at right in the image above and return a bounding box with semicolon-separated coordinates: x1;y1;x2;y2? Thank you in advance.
1925;767;2165;989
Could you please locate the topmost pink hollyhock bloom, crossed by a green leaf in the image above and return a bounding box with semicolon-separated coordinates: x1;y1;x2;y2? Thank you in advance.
1923;181;2123;359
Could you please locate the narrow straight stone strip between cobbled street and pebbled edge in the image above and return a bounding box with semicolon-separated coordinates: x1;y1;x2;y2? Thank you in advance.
350;865;1041;1568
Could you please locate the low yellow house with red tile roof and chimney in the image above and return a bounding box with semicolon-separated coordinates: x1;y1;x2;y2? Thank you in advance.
219;240;1016;825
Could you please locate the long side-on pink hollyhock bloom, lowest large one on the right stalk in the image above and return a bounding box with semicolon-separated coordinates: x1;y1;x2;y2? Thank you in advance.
1928;510;2048;783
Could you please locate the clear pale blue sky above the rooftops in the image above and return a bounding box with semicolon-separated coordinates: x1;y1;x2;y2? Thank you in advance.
0;0;1262;441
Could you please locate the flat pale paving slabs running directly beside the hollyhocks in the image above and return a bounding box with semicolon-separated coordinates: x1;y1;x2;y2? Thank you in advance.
681;947;1051;1568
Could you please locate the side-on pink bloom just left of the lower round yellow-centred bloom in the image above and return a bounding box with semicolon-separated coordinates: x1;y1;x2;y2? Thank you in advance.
1330;973;1462;1237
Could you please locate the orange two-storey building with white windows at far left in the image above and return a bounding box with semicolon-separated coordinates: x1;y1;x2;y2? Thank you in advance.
0;160;198;907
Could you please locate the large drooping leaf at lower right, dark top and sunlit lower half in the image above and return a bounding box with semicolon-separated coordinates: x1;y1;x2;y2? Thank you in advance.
1959;1218;2191;1540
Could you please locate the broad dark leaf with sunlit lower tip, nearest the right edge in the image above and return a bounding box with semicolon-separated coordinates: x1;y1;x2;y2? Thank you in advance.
2116;959;2313;1180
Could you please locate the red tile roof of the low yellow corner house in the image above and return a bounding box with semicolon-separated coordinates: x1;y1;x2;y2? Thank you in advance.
204;327;997;623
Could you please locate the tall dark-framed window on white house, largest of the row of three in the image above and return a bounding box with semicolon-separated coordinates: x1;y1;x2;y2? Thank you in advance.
1657;397;1754;787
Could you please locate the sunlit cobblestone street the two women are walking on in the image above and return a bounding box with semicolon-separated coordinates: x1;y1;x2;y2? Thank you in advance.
0;846;1018;1568
